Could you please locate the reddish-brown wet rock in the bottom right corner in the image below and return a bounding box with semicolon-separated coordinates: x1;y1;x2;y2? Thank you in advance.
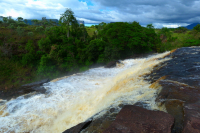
183;102;200;133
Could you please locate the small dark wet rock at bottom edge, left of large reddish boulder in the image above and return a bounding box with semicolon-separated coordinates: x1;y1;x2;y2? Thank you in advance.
63;120;92;133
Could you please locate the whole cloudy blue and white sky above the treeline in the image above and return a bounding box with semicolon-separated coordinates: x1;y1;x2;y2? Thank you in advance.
0;0;200;28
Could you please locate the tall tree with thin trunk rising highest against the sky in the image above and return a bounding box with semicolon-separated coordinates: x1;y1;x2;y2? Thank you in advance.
59;8;78;38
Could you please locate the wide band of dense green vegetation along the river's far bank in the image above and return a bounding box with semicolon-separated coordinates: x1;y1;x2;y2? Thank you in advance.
0;9;200;90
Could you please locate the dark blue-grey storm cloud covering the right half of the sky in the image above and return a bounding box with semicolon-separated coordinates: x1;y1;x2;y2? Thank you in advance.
89;0;200;24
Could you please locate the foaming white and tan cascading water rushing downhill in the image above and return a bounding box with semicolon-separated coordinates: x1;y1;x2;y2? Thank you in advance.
0;52;170;133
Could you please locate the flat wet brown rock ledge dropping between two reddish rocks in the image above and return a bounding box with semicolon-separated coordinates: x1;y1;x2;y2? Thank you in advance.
152;80;200;133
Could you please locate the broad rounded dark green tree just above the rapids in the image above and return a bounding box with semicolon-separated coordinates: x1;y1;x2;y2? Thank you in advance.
97;22;158;60
